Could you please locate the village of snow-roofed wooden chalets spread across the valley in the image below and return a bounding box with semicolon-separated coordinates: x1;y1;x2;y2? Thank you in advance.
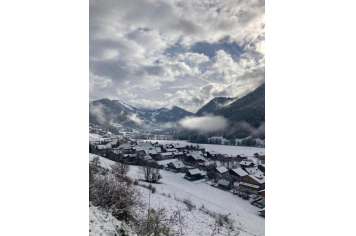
89;123;265;217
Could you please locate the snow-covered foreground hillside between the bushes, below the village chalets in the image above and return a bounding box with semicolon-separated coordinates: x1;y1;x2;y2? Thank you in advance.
89;154;265;236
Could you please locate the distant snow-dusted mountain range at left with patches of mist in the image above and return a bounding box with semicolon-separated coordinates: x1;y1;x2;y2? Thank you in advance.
89;99;193;127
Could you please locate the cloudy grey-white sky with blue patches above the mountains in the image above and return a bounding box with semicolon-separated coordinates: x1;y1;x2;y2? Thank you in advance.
89;0;265;112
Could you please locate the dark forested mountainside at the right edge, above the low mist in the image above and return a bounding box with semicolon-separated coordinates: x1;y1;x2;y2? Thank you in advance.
213;83;265;127
